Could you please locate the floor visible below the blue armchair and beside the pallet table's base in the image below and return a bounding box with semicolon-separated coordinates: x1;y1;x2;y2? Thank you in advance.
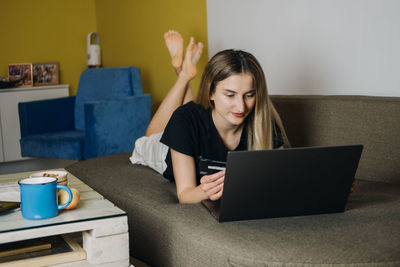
0;158;149;267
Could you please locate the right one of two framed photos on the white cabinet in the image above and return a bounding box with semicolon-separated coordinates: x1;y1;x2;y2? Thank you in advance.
33;62;60;86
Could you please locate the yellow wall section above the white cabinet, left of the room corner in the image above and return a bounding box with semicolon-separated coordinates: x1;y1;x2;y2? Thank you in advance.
0;0;96;95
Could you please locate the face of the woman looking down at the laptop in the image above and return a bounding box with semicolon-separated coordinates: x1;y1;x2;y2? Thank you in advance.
210;73;256;127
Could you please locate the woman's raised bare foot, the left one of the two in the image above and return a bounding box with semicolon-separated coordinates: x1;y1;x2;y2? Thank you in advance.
164;31;183;72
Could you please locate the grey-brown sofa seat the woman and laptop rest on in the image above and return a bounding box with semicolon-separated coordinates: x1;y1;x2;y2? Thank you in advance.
66;153;400;266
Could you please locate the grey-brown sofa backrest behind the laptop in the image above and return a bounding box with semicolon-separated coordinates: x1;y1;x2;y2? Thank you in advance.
272;95;400;184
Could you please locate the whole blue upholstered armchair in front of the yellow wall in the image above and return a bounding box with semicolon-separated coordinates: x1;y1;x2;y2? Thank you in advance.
18;67;151;160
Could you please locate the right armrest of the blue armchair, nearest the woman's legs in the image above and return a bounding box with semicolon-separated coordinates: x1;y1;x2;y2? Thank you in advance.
84;95;151;159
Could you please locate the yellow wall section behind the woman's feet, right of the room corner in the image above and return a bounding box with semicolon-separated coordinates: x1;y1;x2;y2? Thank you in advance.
96;0;208;111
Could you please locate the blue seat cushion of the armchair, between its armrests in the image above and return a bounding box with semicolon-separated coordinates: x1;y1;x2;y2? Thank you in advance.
20;131;85;160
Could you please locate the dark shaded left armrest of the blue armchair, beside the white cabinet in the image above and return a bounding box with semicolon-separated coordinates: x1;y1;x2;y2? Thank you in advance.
18;96;75;137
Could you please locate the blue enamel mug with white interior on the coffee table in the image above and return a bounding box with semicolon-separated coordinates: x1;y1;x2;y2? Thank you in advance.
18;177;72;220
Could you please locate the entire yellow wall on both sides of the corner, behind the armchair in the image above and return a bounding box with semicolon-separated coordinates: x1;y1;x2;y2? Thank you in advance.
0;0;208;111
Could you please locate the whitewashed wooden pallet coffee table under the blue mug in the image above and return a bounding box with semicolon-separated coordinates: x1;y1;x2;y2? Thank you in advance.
0;169;129;267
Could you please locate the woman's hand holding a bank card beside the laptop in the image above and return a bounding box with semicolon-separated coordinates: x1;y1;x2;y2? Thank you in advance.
200;171;225;200
